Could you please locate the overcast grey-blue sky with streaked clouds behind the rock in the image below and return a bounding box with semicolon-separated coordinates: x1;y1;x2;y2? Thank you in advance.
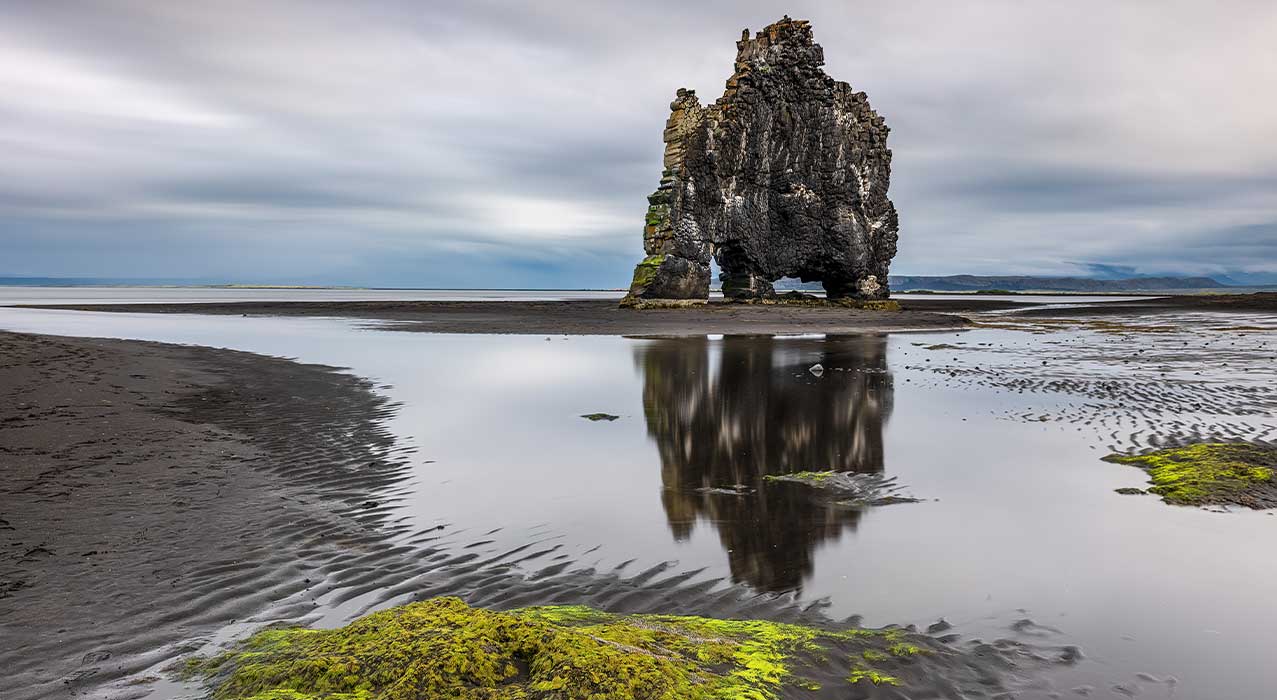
0;0;1277;287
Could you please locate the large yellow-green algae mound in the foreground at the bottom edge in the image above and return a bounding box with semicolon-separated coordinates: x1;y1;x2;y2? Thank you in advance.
184;598;954;700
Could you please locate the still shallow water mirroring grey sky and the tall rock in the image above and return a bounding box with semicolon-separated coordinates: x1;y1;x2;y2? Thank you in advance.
0;309;1277;697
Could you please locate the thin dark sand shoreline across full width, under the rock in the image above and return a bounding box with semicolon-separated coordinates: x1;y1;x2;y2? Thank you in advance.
4;293;1277;337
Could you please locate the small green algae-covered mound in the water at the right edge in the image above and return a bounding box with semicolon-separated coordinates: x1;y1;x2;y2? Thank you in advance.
1105;442;1277;508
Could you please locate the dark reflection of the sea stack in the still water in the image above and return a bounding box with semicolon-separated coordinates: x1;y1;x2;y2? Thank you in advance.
636;337;893;591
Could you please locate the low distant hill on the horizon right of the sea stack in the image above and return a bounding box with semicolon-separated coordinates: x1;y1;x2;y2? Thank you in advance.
890;275;1230;293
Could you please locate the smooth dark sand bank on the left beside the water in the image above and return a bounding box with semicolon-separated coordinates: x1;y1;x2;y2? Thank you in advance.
0;333;404;700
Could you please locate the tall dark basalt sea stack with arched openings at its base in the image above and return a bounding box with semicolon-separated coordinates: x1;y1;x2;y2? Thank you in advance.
623;17;899;305
